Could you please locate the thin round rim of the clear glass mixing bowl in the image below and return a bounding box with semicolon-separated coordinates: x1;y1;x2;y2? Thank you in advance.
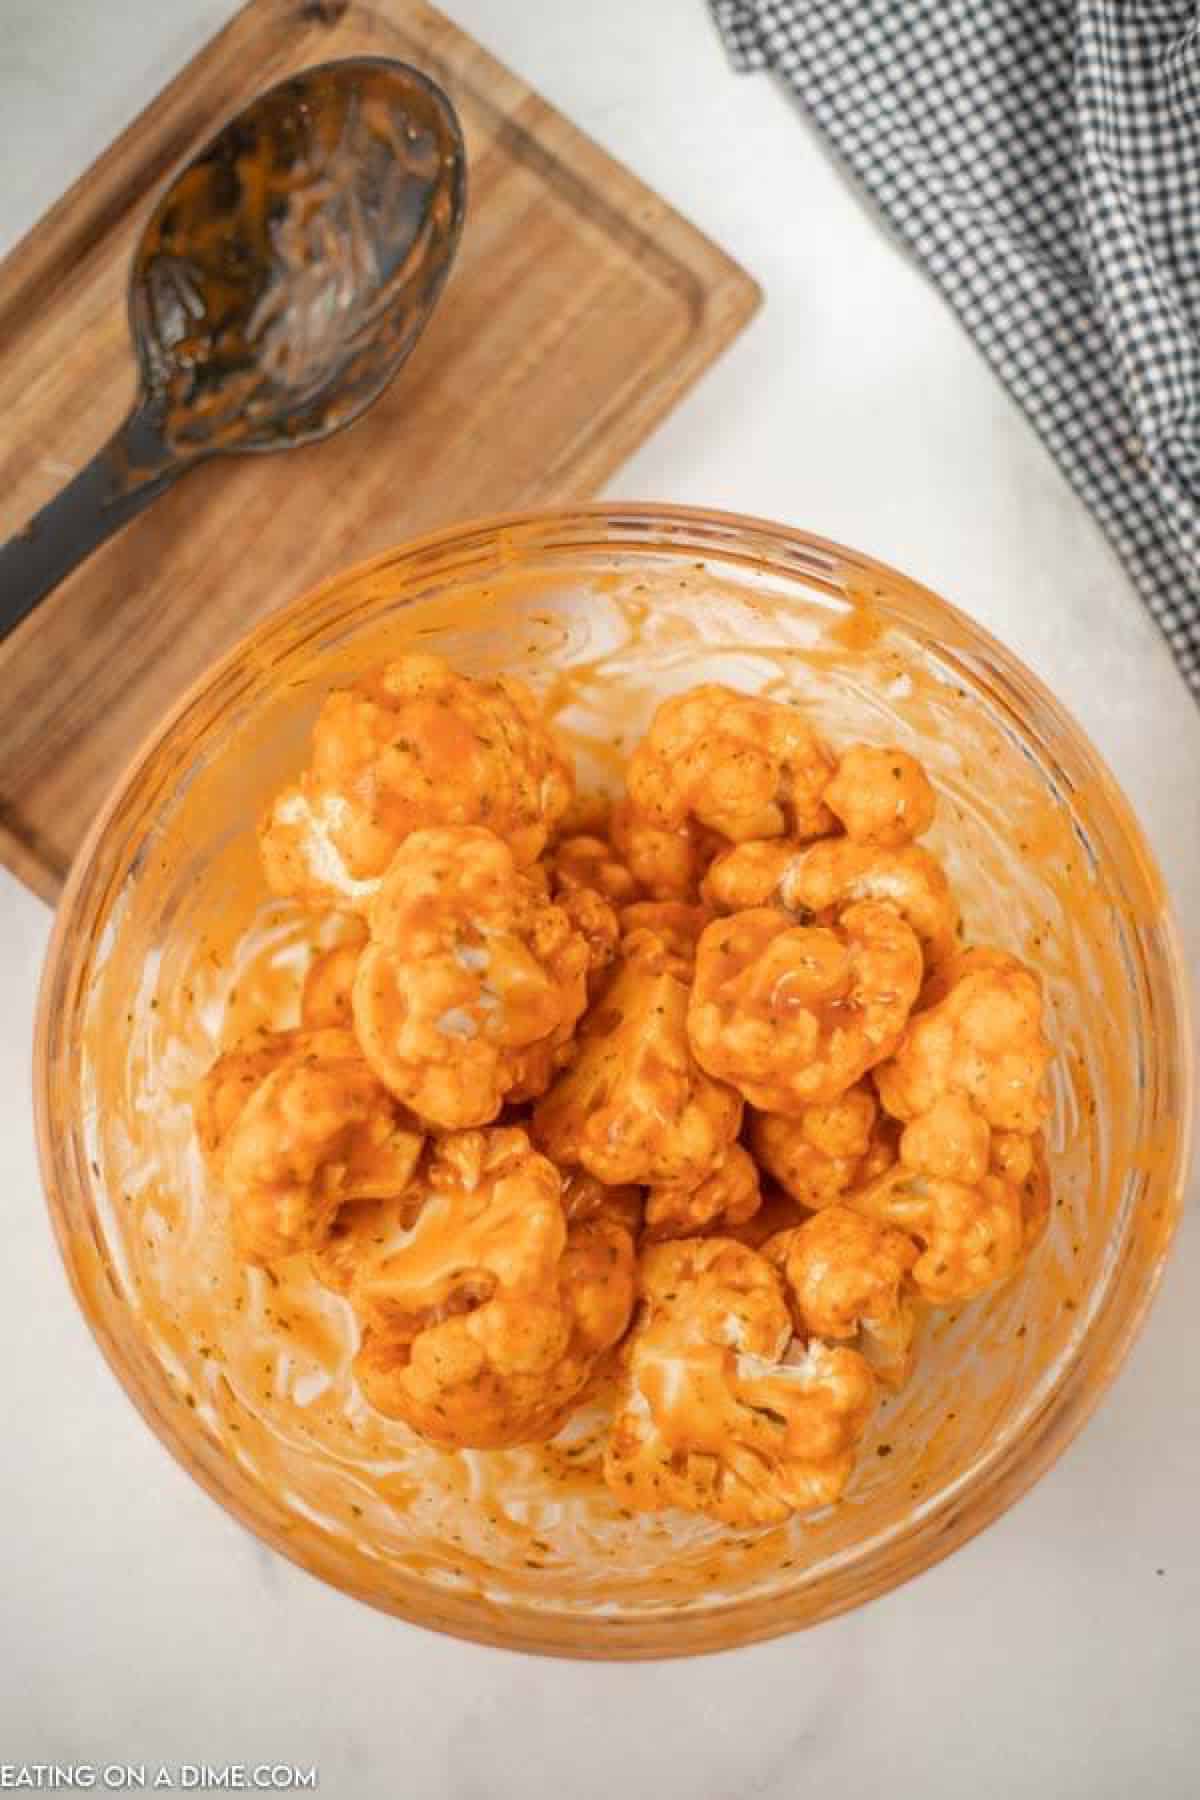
32;499;1196;1661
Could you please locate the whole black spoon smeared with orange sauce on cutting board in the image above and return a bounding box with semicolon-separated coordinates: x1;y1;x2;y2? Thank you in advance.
0;56;466;635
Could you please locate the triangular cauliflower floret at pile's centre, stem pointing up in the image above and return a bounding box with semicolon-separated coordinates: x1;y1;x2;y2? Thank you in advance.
533;934;741;1184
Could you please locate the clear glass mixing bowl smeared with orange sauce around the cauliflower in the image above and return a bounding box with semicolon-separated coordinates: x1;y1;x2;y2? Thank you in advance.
36;506;1193;1656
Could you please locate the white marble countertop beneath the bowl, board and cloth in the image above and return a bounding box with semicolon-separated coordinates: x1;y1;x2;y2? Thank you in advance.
0;0;1200;1800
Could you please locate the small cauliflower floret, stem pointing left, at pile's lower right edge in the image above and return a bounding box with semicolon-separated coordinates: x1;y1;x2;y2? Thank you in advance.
846;1163;1025;1307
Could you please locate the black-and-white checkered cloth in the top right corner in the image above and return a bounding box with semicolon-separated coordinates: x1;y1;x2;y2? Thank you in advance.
709;0;1200;697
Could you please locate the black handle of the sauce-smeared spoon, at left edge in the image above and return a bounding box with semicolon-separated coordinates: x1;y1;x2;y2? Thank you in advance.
0;405;187;637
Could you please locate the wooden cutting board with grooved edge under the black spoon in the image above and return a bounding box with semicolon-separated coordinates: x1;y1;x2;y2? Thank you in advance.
0;0;759;898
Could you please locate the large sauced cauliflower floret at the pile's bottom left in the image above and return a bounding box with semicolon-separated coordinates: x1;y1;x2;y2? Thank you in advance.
351;1129;633;1449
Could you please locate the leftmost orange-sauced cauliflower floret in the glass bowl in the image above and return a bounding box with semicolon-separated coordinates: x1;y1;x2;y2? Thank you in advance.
196;1030;421;1262
